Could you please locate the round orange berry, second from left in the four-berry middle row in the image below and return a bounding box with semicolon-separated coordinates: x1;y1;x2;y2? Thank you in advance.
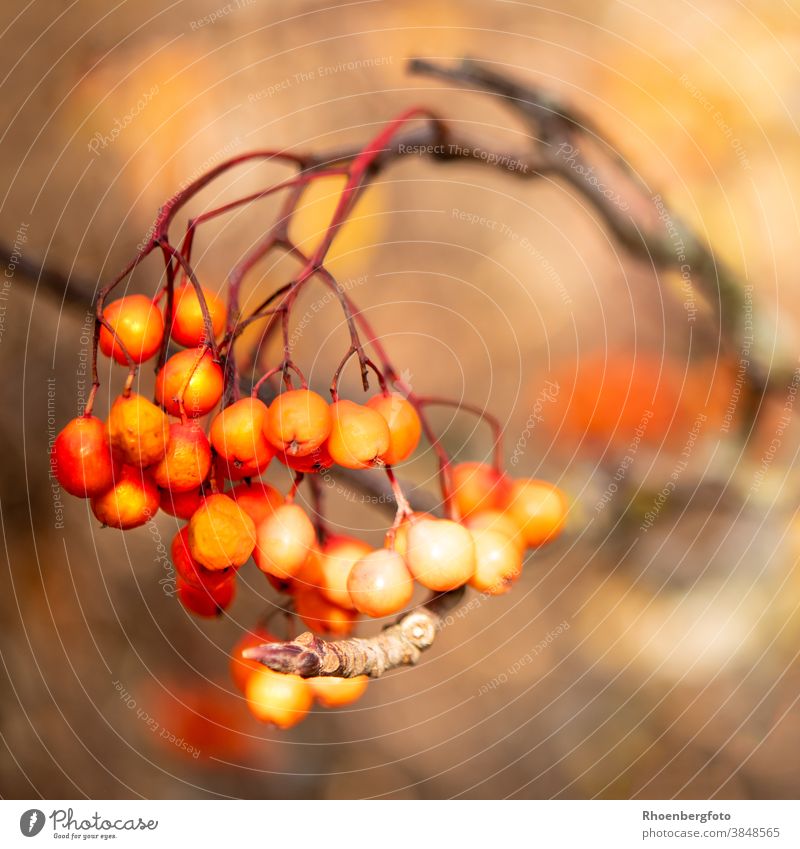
264;389;331;457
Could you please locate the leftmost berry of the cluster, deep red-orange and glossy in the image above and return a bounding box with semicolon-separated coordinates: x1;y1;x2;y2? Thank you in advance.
50;416;115;498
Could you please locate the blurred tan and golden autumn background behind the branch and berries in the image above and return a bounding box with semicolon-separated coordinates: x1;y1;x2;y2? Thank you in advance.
0;0;800;798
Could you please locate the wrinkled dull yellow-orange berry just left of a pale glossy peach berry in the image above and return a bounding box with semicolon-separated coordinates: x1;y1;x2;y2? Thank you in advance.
189;494;256;570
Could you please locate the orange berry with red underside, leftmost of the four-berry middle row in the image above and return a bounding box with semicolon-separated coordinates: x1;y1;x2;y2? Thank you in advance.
210;398;274;479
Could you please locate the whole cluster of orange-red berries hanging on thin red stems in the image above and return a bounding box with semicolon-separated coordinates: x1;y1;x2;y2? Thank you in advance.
52;106;567;728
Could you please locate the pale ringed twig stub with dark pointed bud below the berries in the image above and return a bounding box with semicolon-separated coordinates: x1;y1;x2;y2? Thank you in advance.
244;587;464;678
